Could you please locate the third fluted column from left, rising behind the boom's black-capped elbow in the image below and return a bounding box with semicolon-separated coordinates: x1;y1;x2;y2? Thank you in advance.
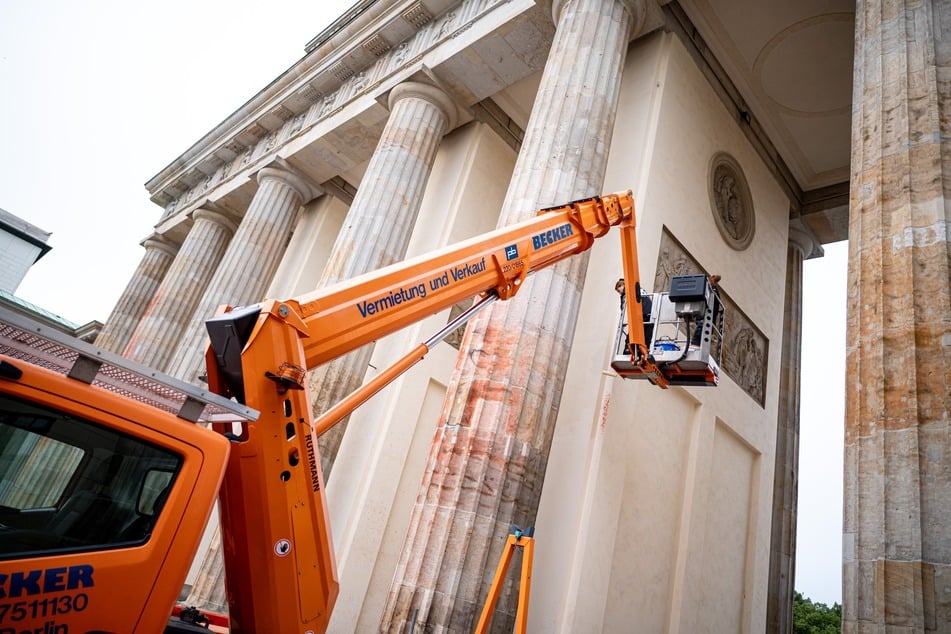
169;166;319;383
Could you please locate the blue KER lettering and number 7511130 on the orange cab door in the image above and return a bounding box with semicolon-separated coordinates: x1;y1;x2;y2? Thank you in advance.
0;564;95;634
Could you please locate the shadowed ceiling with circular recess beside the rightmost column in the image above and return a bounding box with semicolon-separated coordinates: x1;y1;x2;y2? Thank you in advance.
667;0;855;242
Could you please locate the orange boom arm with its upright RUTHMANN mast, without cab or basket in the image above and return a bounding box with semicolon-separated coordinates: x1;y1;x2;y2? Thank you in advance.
207;191;643;632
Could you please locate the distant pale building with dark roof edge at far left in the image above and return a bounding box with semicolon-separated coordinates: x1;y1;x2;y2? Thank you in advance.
0;209;102;342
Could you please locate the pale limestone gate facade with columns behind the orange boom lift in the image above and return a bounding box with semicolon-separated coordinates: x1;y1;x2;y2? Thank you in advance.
96;0;947;632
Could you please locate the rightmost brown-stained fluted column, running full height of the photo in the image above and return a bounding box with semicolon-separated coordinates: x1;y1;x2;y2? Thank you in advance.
842;0;951;633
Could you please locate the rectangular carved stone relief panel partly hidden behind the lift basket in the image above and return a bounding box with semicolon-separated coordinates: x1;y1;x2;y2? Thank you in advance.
645;227;769;406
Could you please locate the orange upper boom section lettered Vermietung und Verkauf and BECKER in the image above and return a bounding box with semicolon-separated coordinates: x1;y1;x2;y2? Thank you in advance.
288;192;634;368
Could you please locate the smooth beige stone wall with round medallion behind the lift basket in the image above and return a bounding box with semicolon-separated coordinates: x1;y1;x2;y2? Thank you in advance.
530;34;788;632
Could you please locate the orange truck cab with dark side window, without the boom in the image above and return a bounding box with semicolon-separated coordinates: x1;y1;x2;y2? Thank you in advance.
0;314;245;632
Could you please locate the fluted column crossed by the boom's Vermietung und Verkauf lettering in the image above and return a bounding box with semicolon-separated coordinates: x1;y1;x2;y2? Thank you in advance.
311;82;456;478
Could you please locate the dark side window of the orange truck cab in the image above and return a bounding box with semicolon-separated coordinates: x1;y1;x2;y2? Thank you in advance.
0;394;182;559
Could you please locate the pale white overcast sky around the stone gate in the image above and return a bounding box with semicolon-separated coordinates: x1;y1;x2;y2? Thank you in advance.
0;0;846;605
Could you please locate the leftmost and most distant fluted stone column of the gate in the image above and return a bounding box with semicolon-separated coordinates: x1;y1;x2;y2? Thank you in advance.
96;235;175;354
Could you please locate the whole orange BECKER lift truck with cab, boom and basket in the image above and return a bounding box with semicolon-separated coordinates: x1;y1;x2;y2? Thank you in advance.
0;191;719;634
